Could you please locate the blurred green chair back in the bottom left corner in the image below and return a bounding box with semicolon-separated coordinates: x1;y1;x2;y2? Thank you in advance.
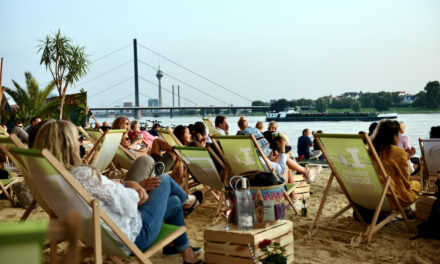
0;220;48;264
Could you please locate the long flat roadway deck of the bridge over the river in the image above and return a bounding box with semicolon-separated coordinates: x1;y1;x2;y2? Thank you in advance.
90;106;269;118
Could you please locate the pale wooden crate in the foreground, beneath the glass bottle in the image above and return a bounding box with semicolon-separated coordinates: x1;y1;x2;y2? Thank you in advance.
204;220;294;264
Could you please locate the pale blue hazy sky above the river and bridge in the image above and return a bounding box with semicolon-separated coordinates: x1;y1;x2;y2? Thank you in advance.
0;0;440;107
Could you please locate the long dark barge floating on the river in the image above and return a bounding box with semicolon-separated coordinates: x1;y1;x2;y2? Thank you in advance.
266;110;397;122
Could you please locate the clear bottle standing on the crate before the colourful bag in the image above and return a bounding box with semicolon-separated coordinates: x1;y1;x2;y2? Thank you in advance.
235;178;254;230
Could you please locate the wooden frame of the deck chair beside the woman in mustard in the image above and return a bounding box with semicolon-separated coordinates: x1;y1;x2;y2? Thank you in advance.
310;132;410;243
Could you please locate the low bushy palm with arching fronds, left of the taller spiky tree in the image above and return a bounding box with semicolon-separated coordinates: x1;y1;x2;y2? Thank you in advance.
5;72;56;124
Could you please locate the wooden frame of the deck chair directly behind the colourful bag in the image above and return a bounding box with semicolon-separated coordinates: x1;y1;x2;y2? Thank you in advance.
211;134;298;214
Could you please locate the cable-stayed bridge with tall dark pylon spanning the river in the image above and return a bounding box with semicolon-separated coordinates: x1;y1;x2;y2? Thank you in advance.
77;39;262;117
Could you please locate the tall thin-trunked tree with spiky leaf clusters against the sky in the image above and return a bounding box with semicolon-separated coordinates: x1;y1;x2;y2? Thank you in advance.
38;30;90;119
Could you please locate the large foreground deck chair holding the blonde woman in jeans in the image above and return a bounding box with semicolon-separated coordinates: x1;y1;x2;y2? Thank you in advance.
11;148;186;263
